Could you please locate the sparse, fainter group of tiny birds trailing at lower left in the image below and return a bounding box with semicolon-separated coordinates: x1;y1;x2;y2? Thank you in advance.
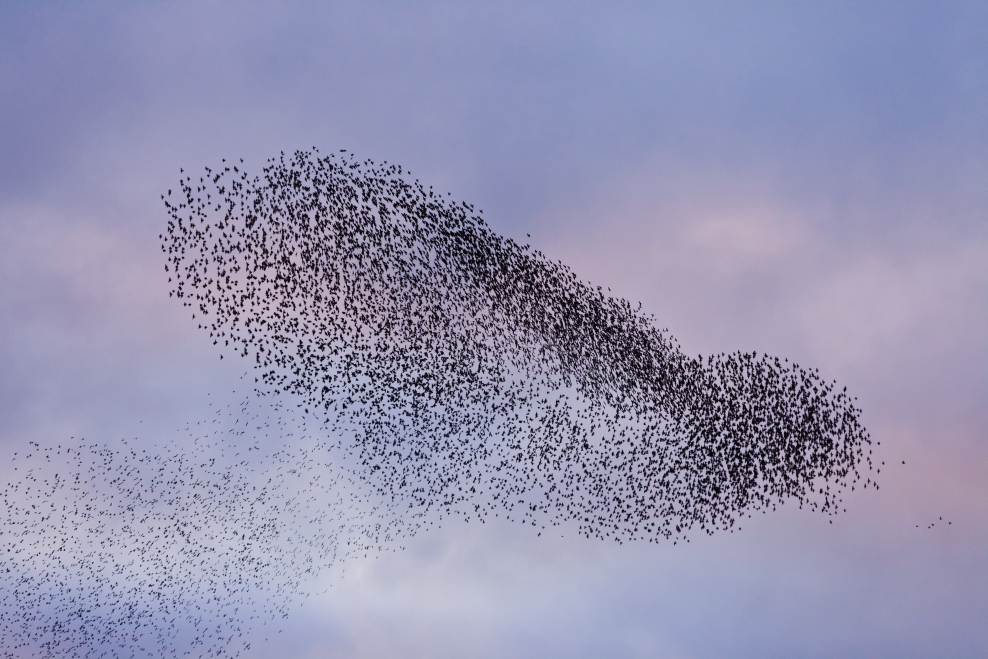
0;399;413;659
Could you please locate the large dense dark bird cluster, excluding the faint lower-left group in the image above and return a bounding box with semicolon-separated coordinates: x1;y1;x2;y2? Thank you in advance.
162;149;870;540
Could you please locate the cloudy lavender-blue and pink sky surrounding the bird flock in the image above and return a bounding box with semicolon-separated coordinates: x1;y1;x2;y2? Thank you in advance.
0;2;988;659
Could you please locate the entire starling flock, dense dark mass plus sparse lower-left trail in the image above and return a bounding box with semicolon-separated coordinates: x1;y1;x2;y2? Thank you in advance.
0;149;874;657
